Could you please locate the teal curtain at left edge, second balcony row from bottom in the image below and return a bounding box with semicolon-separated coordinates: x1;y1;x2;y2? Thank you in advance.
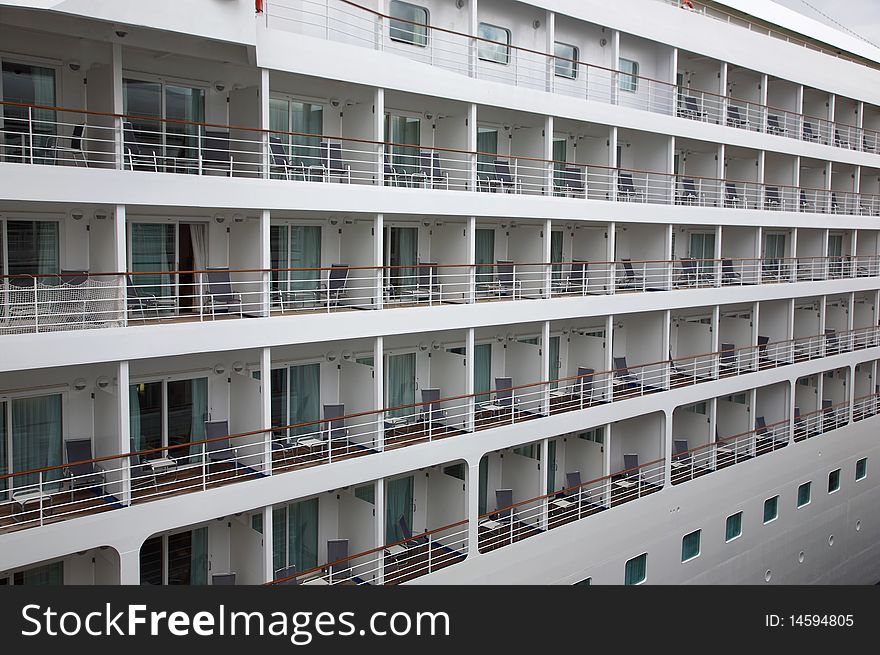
12;394;63;488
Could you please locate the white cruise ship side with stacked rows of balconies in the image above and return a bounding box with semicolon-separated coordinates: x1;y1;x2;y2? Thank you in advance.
0;0;880;585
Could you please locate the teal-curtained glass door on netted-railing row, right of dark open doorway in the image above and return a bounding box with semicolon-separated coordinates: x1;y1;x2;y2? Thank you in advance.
269;225;321;299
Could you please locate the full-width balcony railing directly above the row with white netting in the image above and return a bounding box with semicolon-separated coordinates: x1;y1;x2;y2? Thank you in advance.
0;102;880;216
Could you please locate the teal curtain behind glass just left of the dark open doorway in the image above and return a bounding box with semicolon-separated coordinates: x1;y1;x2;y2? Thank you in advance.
131;223;177;298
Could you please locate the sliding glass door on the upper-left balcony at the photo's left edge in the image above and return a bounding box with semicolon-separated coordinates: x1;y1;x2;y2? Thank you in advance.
0;60;56;164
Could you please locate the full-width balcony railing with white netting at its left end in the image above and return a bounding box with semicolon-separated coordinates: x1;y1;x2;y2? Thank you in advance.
0;255;880;335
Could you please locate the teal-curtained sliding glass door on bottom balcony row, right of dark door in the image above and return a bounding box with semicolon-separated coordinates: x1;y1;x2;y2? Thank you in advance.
272;498;318;575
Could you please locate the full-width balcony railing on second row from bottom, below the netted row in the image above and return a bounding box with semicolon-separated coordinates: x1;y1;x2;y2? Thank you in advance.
0;327;880;534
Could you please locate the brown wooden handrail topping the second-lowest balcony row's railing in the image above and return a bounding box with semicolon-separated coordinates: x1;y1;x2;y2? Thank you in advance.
0;326;880;480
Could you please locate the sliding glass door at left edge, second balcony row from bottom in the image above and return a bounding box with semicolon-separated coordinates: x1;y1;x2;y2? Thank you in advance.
0;394;64;500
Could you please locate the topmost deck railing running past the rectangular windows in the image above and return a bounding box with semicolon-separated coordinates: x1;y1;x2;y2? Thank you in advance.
265;0;880;153
